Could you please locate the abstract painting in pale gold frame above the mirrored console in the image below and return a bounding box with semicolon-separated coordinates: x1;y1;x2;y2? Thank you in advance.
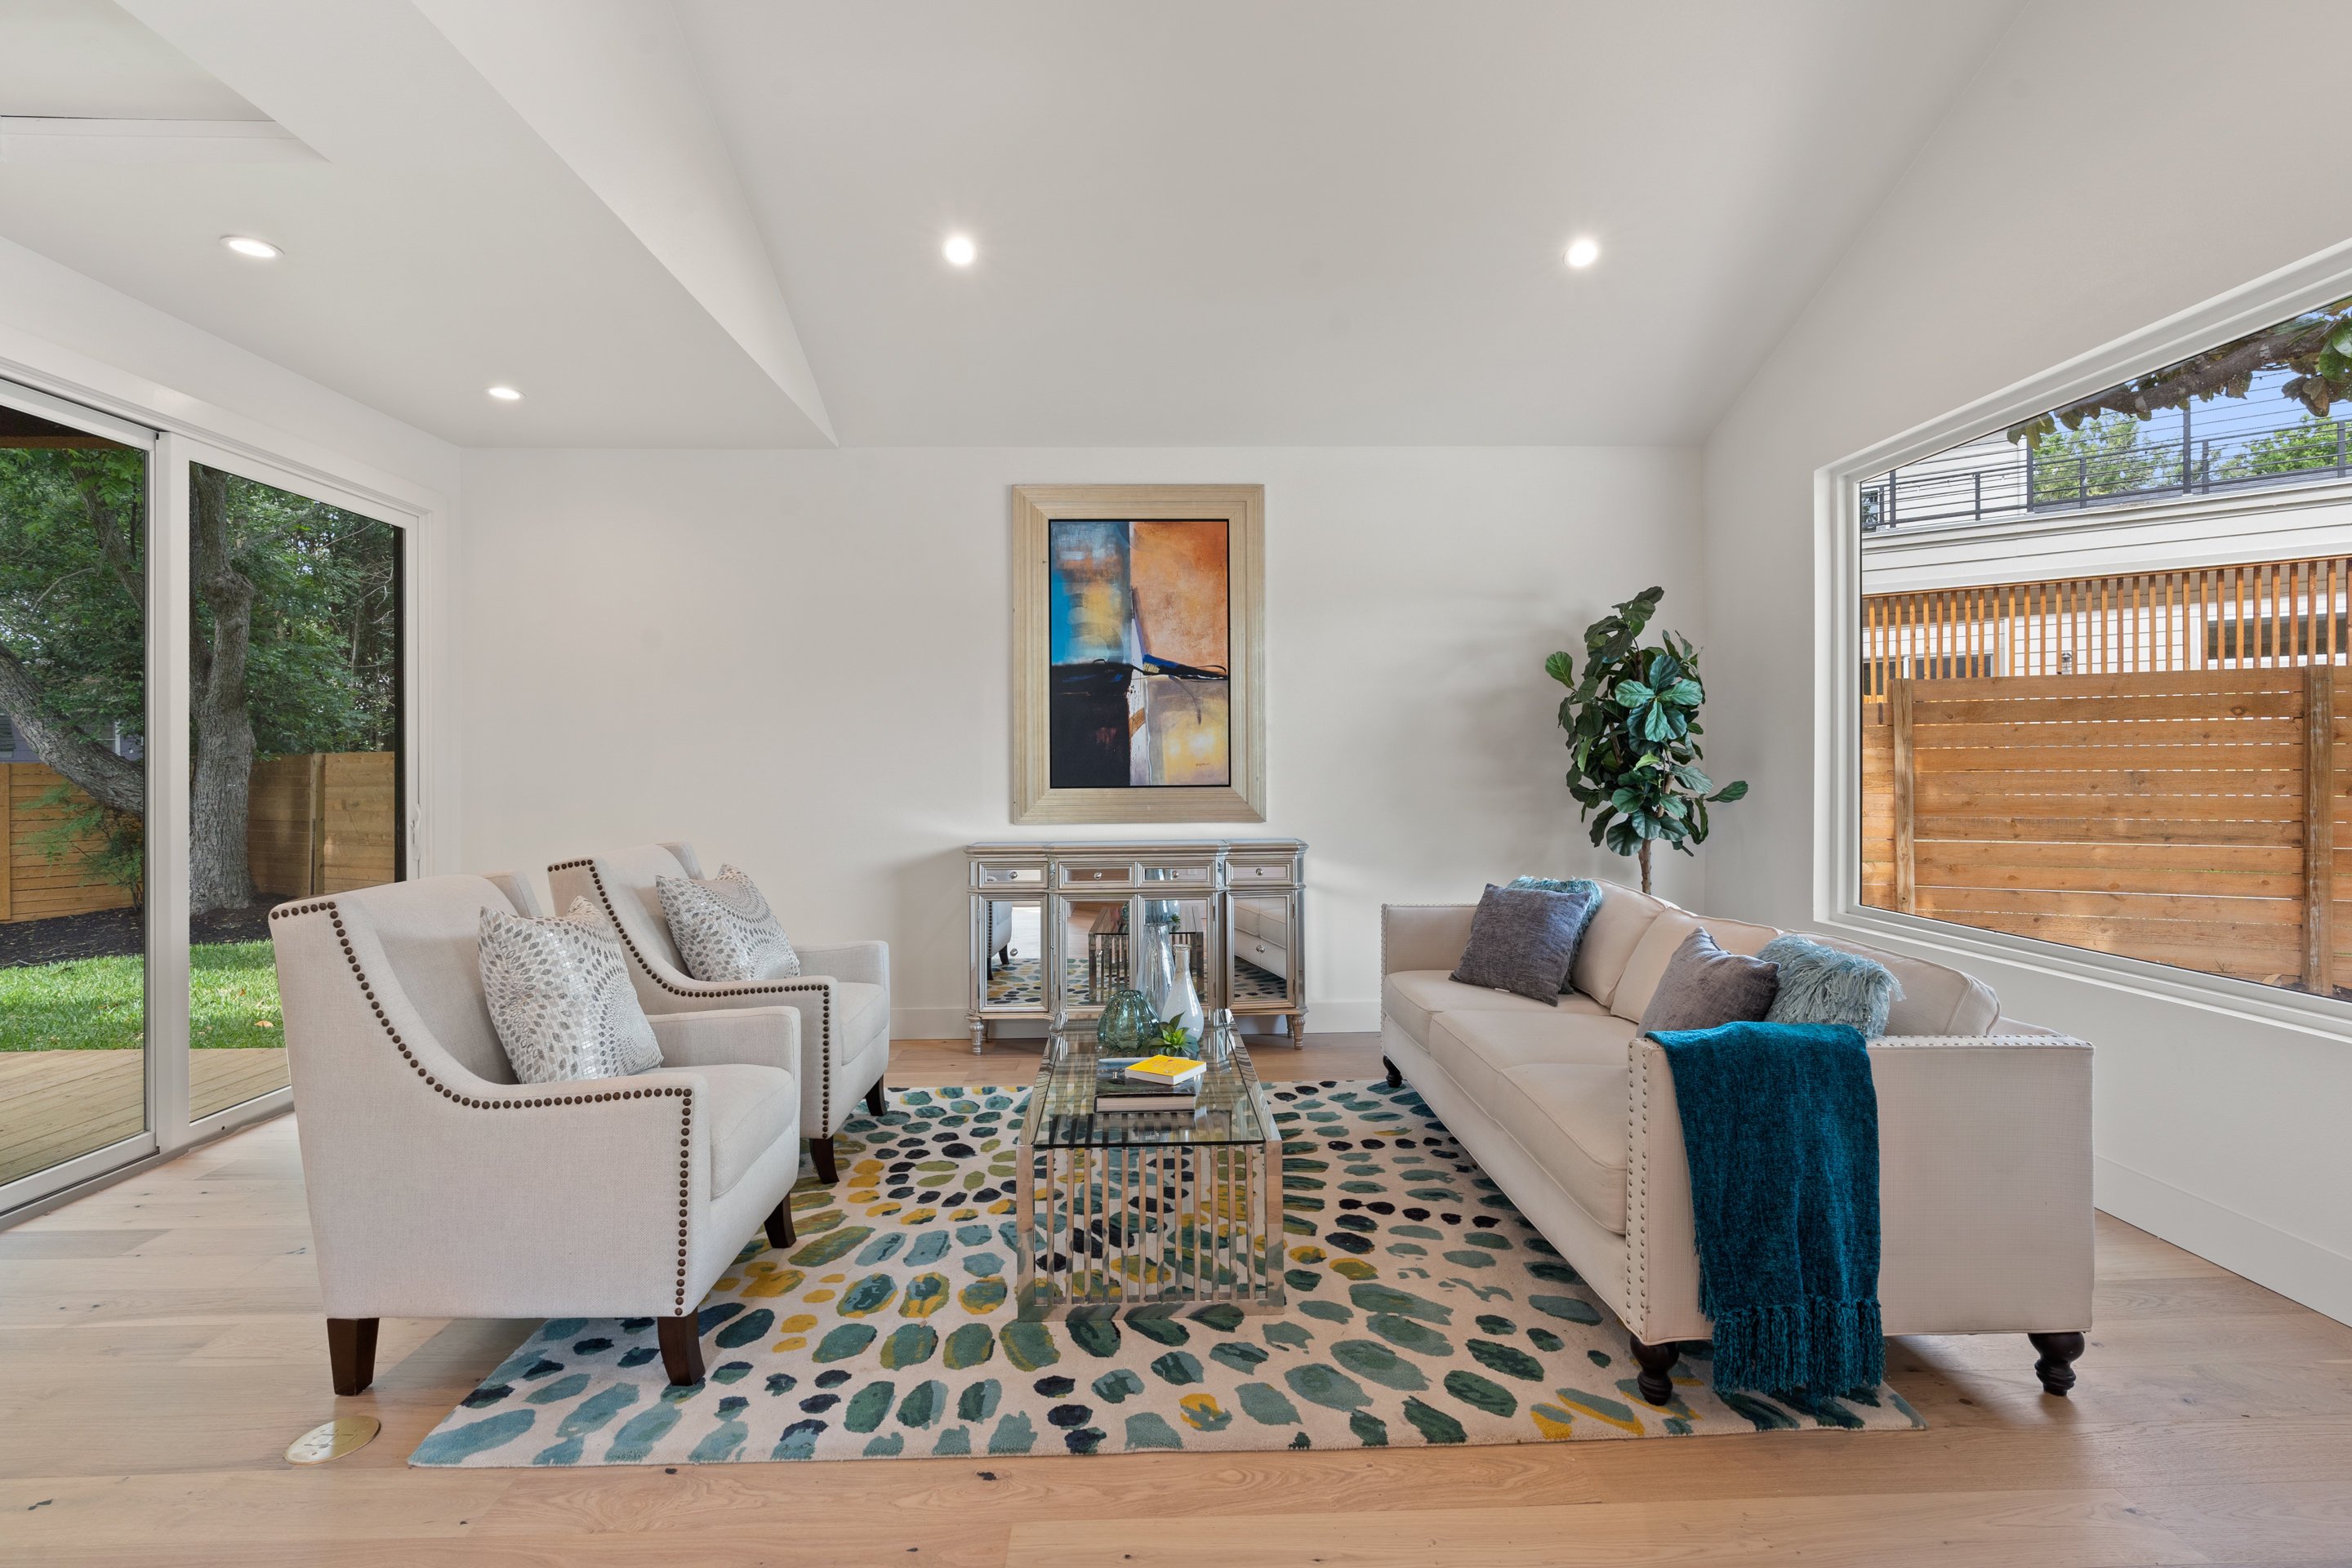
1013;484;1265;822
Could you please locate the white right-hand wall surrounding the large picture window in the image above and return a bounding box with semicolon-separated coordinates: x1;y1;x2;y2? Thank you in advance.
1705;2;2352;1319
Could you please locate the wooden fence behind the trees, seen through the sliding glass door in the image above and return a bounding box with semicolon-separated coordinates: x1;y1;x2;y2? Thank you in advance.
0;752;400;921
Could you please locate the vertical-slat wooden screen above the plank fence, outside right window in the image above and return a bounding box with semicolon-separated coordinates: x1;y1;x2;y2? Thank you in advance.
1863;555;2352;698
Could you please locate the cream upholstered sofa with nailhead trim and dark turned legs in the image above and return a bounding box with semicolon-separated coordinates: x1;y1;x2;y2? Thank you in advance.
1381;881;2091;1404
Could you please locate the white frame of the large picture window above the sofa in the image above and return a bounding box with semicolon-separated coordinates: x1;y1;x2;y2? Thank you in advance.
1813;242;2352;1041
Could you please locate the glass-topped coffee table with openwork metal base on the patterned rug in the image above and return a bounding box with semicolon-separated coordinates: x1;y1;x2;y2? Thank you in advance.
1013;1020;1284;1321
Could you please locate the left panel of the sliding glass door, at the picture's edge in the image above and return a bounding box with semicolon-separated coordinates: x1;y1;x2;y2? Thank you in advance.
0;388;155;1201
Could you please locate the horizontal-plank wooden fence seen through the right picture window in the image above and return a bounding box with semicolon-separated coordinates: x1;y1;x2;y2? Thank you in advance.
1863;667;2352;995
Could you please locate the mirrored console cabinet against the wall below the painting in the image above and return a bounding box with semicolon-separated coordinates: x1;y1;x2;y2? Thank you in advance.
964;840;1307;1055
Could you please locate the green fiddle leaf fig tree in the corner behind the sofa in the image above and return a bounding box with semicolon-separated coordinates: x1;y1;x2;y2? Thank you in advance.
1543;588;1748;893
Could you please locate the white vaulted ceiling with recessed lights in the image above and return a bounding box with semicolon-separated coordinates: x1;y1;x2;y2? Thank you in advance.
0;0;2016;447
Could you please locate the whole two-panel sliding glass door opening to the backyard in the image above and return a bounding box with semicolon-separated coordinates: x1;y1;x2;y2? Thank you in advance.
0;383;414;1218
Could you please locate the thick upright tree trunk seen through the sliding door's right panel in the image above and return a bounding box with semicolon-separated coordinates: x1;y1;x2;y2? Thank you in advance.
188;463;254;915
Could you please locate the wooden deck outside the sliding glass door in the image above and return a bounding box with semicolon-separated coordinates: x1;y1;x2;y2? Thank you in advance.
0;1051;287;1183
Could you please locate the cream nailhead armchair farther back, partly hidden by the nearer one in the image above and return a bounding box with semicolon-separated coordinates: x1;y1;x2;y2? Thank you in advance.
548;844;889;1185
